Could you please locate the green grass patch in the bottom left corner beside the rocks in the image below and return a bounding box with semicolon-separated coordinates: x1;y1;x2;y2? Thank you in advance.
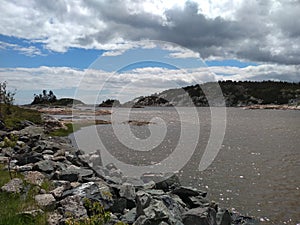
0;165;47;225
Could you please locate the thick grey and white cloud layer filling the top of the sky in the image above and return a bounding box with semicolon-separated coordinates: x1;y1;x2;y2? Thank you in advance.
0;0;300;65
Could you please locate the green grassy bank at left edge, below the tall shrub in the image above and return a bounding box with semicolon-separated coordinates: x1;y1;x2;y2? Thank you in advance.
0;104;42;129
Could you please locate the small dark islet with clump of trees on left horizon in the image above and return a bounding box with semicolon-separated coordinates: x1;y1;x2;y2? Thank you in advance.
31;90;84;106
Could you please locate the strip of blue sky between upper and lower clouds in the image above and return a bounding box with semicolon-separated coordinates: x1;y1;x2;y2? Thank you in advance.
0;35;257;71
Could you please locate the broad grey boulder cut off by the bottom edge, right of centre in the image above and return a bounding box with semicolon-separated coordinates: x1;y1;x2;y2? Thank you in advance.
182;207;217;225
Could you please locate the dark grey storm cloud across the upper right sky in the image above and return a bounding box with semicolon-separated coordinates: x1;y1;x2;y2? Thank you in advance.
75;0;300;64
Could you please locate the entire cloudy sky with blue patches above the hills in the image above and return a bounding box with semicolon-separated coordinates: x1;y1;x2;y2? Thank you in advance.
0;0;300;104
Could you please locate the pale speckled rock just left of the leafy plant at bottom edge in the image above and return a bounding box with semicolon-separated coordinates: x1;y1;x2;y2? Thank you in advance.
60;195;87;218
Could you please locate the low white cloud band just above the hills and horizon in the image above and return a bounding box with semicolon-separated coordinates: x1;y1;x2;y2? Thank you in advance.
0;64;300;103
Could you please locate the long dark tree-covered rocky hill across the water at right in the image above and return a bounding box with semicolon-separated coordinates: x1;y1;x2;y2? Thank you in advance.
131;80;300;106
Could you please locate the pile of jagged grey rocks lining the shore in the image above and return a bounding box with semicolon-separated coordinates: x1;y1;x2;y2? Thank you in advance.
0;125;257;225
